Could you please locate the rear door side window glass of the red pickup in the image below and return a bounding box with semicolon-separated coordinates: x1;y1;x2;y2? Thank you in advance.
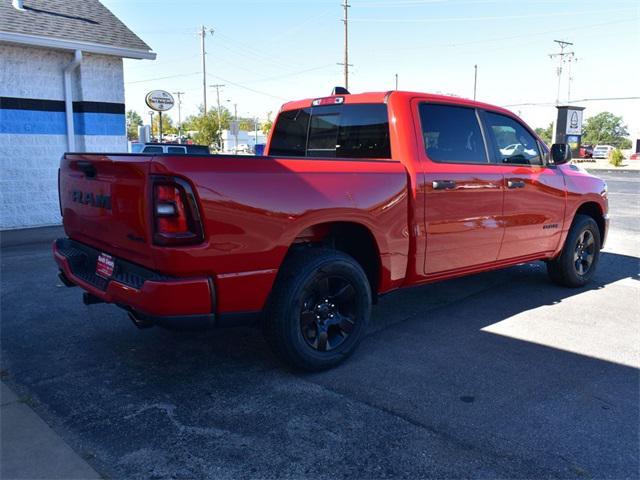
419;103;488;163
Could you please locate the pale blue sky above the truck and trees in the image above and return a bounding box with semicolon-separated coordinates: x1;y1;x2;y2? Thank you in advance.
101;0;640;135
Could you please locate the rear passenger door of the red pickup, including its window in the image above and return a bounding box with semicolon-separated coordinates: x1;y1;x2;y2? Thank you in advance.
414;100;504;275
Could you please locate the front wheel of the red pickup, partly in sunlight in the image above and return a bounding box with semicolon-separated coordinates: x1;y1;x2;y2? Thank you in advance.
547;215;601;288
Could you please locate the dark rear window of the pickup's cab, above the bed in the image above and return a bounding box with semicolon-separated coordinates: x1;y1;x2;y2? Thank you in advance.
269;104;391;159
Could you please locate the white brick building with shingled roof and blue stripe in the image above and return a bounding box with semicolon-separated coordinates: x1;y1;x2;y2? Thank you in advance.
0;0;155;230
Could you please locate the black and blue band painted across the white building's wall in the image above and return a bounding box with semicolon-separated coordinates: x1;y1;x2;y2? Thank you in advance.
0;97;126;136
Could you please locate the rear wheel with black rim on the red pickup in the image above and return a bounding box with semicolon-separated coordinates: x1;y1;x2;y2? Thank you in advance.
263;247;371;371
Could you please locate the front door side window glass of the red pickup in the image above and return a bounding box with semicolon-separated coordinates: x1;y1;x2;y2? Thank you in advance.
484;112;542;165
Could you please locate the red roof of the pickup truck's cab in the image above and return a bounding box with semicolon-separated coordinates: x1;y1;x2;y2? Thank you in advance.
280;90;513;115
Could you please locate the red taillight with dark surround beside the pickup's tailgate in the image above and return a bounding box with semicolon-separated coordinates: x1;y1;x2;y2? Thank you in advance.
153;177;204;246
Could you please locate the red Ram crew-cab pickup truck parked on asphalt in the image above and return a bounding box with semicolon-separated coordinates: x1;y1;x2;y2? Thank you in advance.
54;91;608;370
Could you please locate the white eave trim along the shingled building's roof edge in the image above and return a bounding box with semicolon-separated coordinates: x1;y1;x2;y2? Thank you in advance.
0;31;156;60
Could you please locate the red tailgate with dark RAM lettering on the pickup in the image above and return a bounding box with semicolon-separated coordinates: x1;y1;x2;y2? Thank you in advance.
59;154;154;268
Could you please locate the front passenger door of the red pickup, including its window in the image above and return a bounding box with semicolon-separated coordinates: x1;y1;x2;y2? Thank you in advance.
482;111;566;260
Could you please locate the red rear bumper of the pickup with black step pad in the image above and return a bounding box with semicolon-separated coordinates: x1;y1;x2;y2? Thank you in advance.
53;238;216;328
